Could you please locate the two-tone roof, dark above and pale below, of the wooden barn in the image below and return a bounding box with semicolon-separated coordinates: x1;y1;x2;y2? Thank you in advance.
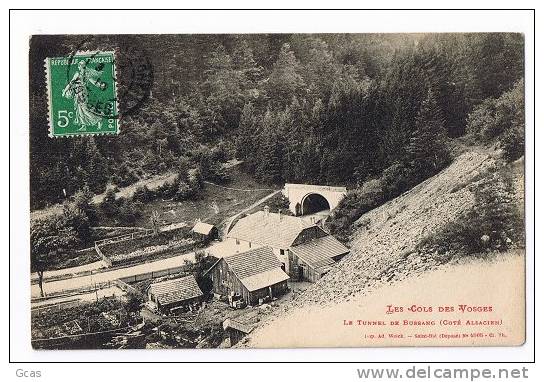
223;247;289;292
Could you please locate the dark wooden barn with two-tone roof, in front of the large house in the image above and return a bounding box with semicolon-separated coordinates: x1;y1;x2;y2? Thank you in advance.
204;247;289;305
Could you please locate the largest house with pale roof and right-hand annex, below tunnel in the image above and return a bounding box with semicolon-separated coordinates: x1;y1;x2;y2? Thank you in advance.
227;207;349;281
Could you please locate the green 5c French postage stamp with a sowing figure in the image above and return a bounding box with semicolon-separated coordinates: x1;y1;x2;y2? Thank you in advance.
45;52;119;137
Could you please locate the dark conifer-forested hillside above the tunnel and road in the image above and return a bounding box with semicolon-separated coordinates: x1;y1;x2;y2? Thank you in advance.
30;34;524;210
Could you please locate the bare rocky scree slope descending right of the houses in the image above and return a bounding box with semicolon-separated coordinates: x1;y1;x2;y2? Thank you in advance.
283;150;501;310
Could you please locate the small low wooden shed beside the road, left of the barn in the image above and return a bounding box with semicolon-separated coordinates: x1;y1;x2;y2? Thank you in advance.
147;275;204;313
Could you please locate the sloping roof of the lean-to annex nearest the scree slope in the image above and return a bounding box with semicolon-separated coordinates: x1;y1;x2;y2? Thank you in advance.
291;235;349;269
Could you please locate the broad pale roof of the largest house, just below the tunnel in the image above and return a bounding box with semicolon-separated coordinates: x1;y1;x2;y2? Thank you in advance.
227;211;315;249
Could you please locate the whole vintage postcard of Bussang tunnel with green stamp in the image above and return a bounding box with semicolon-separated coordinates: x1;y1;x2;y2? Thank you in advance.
27;33;526;349
